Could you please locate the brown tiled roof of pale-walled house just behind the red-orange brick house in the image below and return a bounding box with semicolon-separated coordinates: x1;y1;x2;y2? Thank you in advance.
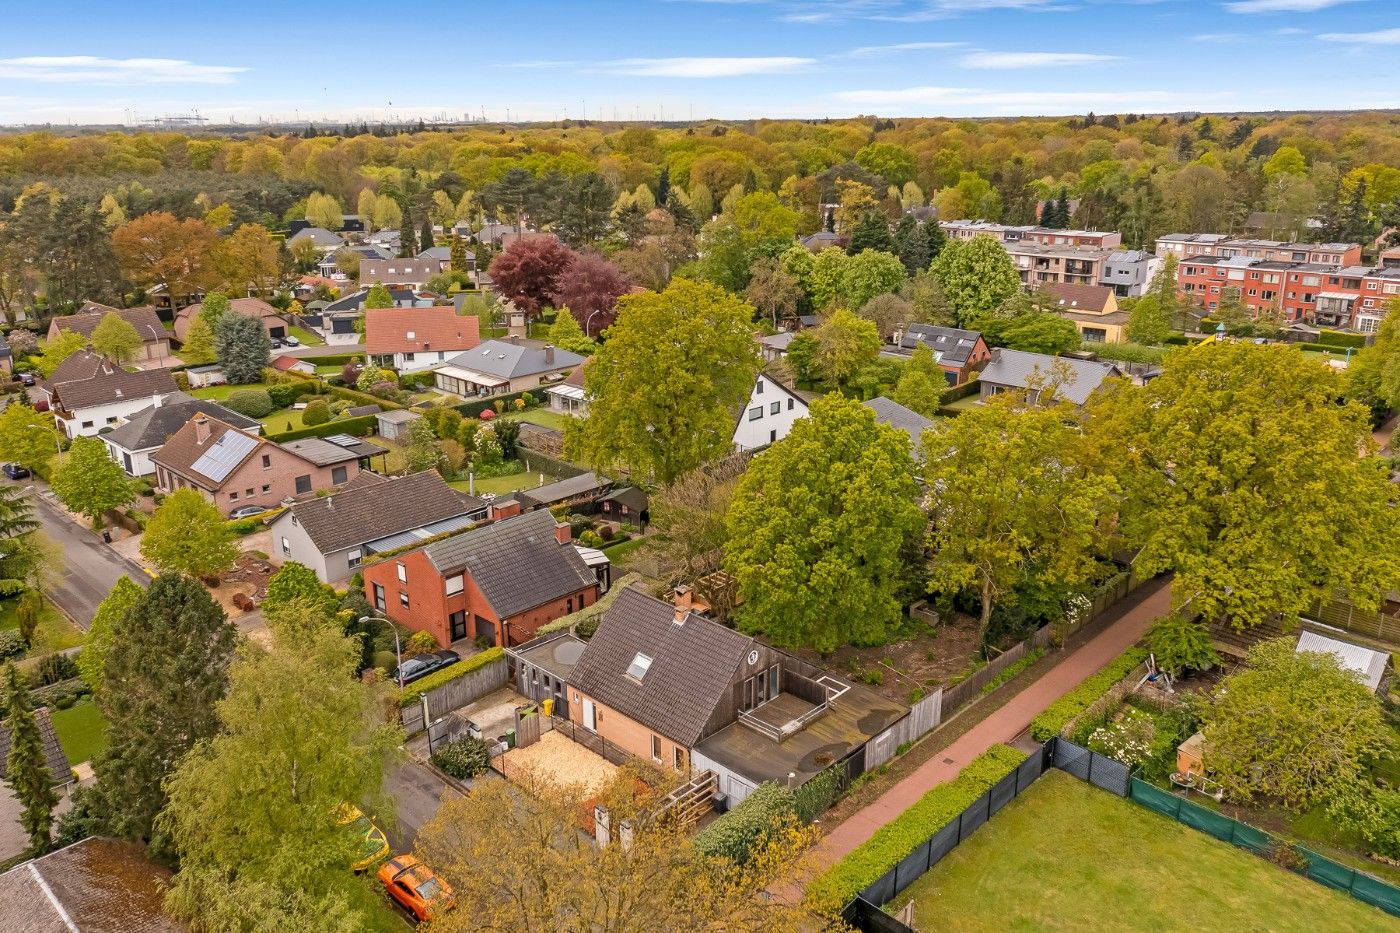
279;469;486;553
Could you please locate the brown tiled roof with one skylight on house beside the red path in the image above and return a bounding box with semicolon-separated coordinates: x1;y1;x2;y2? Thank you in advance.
571;587;753;748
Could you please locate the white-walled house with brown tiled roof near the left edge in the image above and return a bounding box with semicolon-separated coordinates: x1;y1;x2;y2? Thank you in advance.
35;350;178;438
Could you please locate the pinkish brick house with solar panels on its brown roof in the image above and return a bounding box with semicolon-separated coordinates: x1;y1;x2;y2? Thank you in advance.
151;413;382;516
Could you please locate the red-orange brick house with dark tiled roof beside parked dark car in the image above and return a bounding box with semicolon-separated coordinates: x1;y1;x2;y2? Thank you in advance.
361;510;606;647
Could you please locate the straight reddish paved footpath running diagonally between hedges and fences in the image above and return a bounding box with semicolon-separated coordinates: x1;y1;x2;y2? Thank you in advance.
813;580;1172;870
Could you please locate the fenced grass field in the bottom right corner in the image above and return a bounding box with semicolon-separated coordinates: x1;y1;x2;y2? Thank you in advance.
895;770;1400;933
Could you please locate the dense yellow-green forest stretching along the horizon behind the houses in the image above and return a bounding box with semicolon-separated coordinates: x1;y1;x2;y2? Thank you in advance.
0;112;1400;317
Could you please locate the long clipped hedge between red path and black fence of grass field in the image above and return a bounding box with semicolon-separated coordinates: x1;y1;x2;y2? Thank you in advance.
806;745;1026;916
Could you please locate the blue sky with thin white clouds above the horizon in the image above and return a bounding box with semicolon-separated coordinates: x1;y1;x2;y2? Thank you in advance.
0;0;1400;123
